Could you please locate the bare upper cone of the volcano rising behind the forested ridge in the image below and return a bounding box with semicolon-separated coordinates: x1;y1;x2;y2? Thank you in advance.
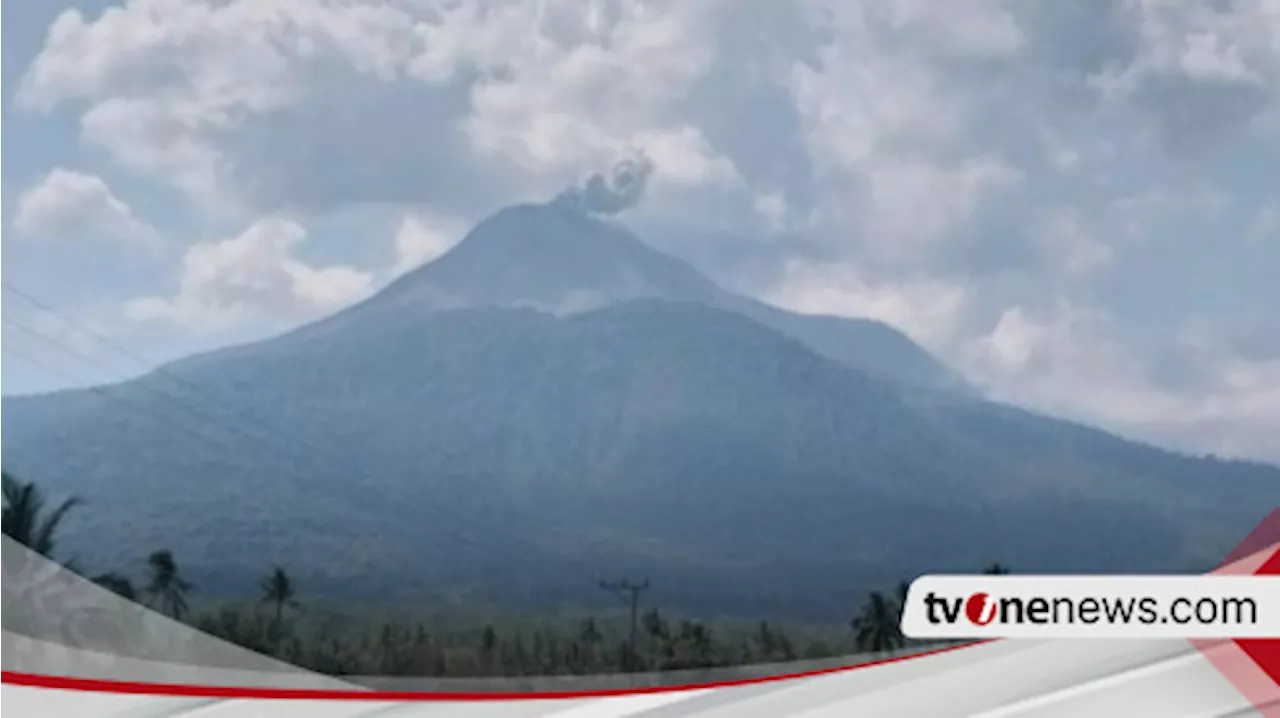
290;202;965;390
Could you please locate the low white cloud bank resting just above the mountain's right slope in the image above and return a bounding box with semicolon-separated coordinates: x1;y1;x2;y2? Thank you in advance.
952;303;1280;461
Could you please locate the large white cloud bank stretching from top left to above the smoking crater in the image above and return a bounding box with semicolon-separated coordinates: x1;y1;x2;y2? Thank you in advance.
19;0;732;211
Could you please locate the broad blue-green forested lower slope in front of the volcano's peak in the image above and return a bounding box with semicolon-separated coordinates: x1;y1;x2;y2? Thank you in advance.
0;299;1280;618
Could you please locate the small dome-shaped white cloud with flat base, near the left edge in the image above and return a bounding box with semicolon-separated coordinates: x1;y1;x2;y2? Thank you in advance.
13;168;157;243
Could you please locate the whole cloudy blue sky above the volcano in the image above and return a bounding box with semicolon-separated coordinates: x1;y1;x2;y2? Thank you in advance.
0;0;1280;461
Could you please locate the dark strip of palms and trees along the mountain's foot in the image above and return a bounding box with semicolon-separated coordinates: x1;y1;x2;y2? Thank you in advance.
0;471;1006;677
